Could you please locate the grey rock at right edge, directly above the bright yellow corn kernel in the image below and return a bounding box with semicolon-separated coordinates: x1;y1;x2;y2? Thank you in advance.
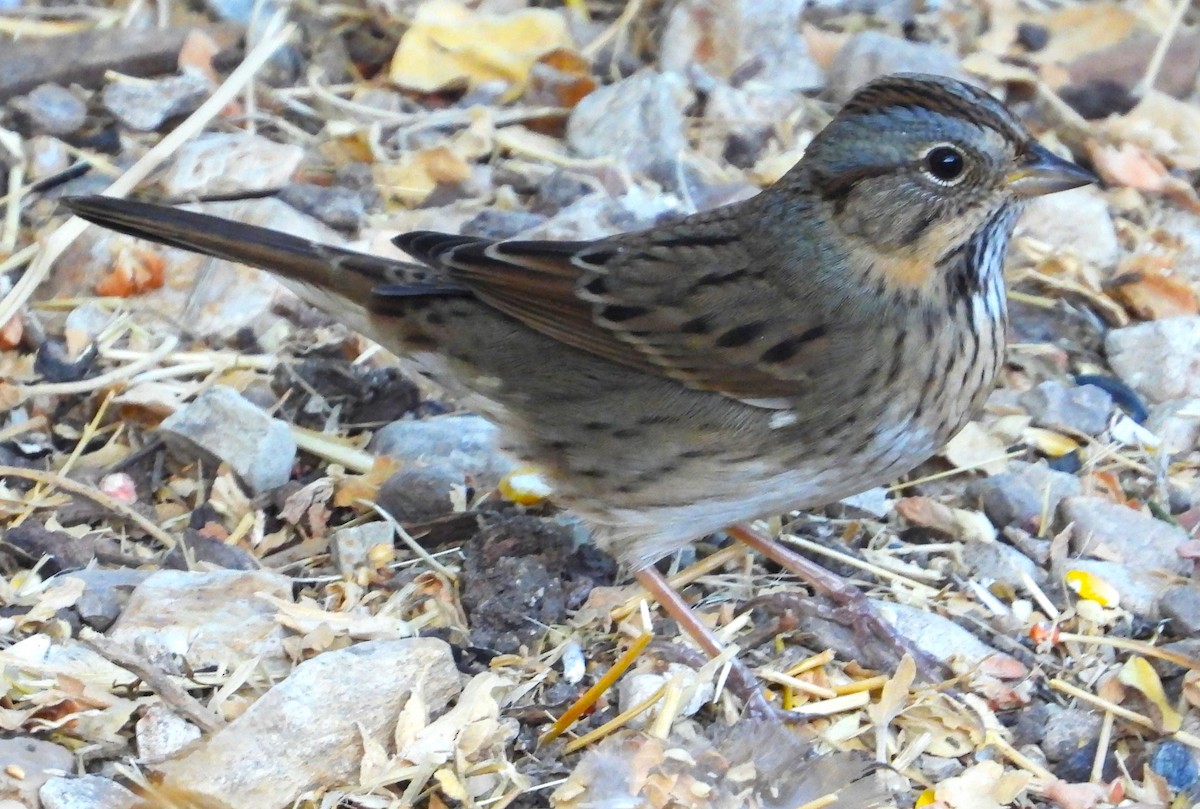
1060;497;1192;575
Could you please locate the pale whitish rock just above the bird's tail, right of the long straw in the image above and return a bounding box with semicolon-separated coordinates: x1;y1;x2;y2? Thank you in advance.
162;133;304;199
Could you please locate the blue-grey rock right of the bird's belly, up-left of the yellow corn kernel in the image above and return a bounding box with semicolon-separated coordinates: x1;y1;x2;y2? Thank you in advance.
967;461;1082;534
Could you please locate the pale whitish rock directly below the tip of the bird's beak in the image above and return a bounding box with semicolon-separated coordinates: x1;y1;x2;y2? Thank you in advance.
1019;186;1121;271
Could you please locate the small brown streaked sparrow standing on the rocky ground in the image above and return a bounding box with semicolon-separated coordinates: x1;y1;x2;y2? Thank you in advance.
66;74;1096;700
